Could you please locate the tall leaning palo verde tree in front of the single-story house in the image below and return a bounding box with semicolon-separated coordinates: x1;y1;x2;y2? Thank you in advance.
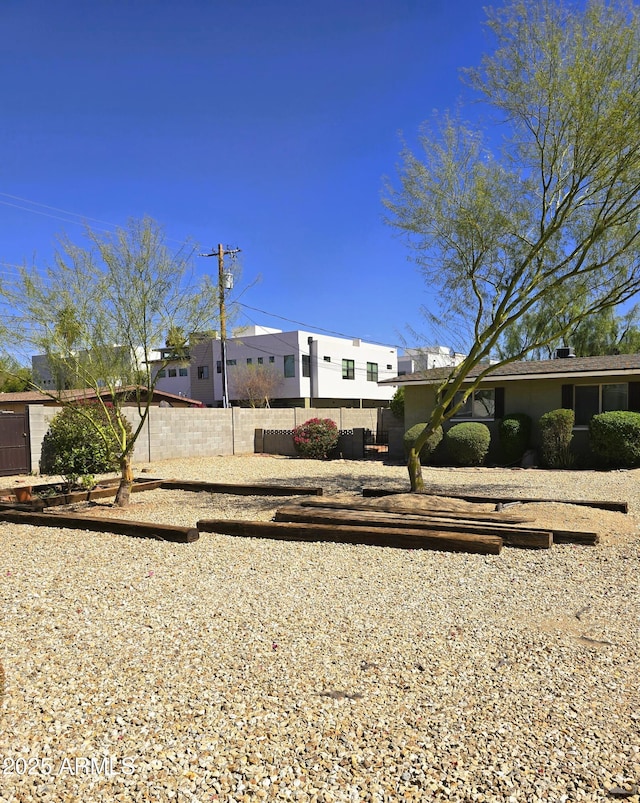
385;0;640;491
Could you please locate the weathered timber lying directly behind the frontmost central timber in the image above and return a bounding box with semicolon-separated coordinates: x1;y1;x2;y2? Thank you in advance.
275;504;553;549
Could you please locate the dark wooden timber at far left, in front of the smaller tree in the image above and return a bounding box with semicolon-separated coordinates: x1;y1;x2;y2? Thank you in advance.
0;510;200;544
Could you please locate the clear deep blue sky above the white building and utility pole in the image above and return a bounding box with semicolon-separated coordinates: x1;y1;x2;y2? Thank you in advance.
0;0;486;354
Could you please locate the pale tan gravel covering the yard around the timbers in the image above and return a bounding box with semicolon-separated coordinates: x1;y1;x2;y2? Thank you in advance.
0;455;640;803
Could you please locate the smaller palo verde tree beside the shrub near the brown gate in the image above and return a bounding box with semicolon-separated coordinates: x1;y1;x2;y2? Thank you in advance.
0;218;217;505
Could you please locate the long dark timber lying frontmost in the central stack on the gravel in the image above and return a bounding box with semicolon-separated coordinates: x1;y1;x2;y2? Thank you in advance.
197;519;503;555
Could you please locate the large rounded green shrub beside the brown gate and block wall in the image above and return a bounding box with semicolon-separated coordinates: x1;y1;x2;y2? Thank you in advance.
40;404;127;490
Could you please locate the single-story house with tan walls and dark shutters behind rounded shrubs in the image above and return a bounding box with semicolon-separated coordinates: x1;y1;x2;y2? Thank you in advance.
387;354;640;458
